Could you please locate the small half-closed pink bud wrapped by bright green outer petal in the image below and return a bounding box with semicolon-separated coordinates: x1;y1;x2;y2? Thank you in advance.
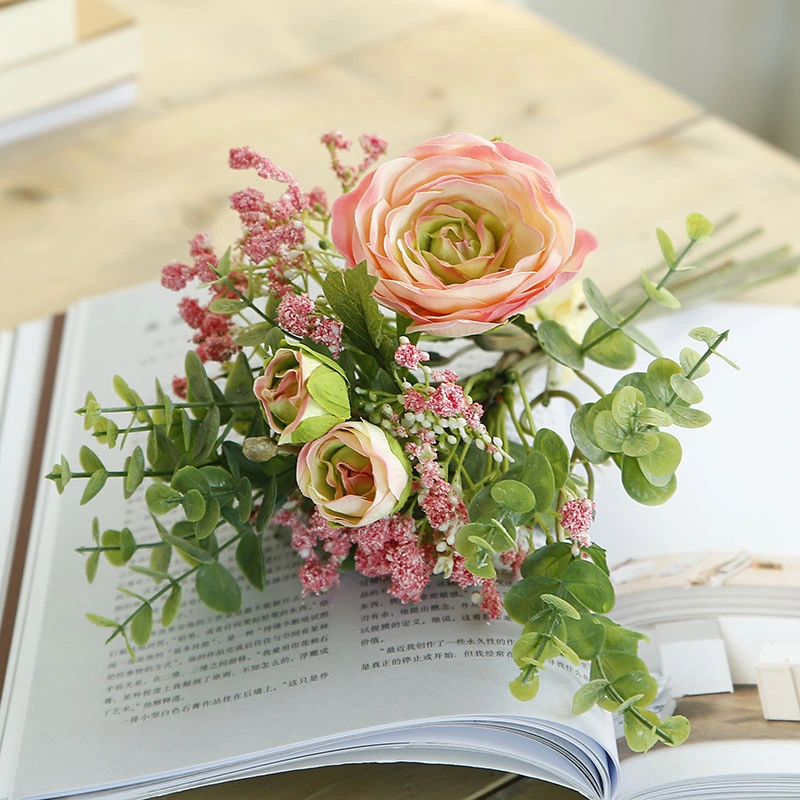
253;344;350;444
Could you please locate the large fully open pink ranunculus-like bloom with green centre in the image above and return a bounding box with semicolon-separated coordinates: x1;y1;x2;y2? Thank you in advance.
332;133;597;337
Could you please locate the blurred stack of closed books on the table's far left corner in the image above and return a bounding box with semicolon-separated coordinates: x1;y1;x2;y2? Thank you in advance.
0;0;139;145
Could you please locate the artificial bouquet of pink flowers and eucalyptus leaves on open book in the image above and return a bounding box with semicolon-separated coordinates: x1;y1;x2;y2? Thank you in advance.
48;134;752;751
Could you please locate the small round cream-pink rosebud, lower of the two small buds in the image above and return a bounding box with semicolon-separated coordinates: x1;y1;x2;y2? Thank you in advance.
297;420;411;528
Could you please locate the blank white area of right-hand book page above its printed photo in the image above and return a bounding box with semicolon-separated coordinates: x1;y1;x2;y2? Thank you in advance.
592;303;800;564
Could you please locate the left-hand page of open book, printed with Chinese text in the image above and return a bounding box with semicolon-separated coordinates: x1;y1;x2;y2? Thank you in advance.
9;287;614;798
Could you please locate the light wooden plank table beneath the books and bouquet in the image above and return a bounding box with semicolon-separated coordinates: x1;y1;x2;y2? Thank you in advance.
0;0;800;800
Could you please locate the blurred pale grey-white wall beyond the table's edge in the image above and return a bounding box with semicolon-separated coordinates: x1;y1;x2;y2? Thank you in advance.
511;0;800;155
